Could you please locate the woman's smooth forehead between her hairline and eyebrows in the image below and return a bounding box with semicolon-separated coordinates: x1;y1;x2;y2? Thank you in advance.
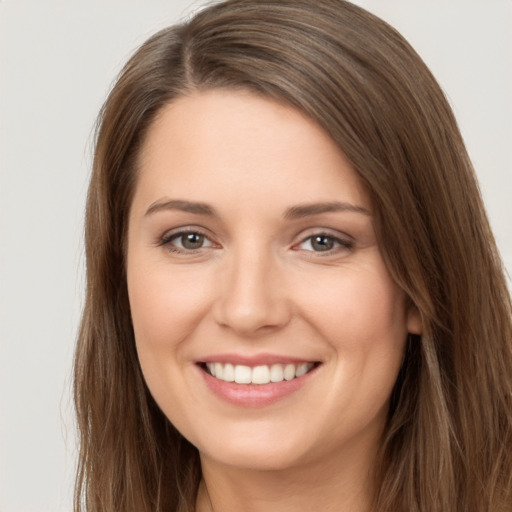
136;90;369;213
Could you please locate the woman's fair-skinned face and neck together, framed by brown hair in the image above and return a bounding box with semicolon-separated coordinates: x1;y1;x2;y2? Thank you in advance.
127;90;421;512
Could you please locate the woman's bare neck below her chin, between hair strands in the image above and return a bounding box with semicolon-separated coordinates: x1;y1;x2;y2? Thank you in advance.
196;444;375;512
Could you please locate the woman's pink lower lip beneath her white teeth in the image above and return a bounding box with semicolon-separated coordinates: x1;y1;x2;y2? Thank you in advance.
199;368;316;407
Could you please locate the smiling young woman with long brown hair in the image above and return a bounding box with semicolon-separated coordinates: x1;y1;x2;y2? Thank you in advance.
75;0;512;512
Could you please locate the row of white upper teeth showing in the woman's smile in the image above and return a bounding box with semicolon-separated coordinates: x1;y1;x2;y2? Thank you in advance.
206;363;314;384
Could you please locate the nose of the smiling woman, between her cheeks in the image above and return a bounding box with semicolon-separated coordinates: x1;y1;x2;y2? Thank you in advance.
214;247;292;337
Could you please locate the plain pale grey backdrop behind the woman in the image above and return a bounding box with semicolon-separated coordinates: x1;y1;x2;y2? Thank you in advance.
0;0;512;512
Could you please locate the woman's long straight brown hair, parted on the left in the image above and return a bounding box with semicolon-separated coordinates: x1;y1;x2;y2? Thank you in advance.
74;0;512;512
